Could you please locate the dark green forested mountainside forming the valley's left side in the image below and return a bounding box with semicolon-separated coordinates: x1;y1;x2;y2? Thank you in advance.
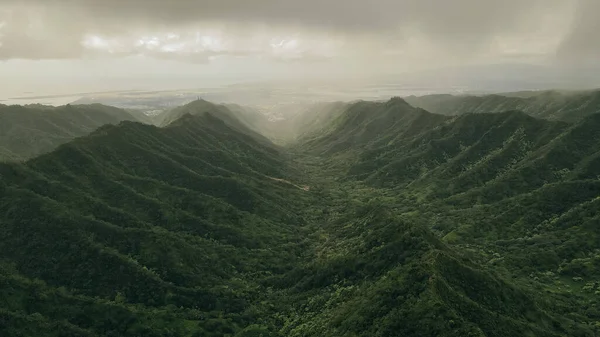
0;114;306;336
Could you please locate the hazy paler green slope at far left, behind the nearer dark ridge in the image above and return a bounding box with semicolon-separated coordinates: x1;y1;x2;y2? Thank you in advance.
0;104;138;161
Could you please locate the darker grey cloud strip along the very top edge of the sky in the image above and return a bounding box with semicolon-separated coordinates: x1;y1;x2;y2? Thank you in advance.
4;0;568;35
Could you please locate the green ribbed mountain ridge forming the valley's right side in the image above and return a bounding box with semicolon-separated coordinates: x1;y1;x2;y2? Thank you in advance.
296;97;600;335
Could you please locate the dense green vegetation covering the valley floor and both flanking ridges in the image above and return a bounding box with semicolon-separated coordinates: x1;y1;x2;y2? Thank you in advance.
0;98;600;337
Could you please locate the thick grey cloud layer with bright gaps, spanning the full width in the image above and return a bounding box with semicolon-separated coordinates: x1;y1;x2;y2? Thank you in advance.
0;0;600;63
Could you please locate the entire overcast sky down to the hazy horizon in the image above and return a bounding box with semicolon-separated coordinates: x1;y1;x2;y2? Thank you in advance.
0;0;600;99
